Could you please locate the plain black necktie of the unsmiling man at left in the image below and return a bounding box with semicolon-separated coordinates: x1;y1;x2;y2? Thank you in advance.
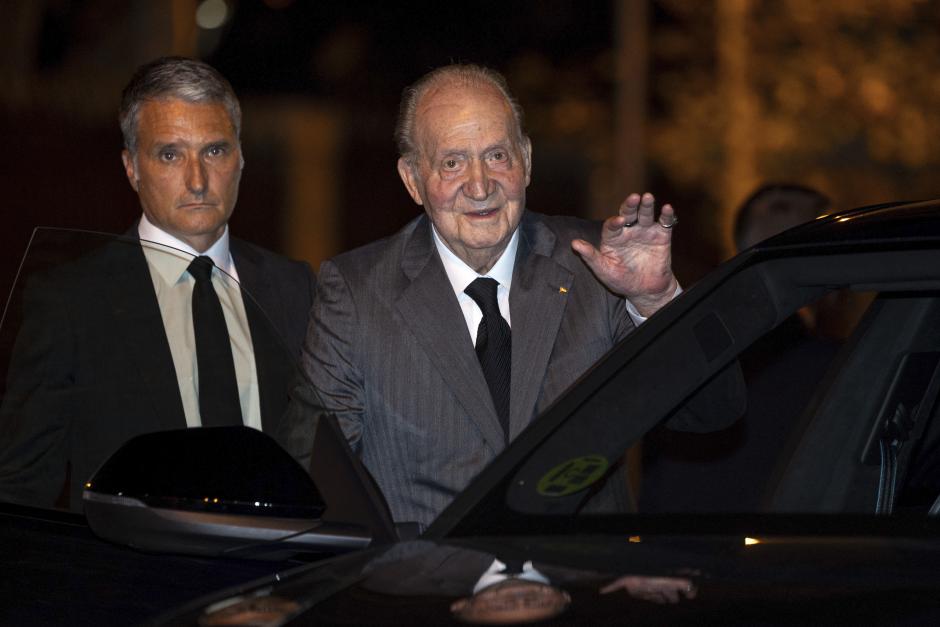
189;256;242;427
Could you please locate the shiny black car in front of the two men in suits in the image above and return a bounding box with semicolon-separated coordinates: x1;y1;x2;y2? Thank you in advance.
1;201;940;625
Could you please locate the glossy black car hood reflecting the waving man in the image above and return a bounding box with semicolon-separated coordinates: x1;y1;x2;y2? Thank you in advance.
158;519;940;625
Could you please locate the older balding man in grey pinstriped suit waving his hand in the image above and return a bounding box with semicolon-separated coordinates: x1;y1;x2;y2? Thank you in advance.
283;65;740;525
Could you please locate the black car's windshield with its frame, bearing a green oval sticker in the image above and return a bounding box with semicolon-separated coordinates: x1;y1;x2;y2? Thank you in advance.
430;207;940;536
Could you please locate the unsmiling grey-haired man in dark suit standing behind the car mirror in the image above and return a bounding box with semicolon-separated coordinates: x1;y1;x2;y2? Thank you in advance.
0;57;315;509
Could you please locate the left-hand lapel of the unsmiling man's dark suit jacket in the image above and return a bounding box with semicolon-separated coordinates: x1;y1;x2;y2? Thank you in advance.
105;239;186;429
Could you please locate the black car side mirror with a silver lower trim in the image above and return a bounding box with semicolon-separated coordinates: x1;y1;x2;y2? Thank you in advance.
83;426;385;559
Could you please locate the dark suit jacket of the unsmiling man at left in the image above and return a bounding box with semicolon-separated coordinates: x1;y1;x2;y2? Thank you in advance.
0;232;315;509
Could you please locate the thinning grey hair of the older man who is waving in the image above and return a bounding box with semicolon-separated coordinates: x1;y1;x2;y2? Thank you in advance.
395;63;526;167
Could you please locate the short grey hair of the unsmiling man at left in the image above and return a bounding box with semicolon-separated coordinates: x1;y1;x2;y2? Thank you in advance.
118;57;242;156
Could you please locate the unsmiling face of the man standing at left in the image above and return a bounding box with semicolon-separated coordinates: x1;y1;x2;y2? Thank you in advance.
121;99;242;252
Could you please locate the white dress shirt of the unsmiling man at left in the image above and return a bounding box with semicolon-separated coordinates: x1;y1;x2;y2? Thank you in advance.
137;216;261;430
